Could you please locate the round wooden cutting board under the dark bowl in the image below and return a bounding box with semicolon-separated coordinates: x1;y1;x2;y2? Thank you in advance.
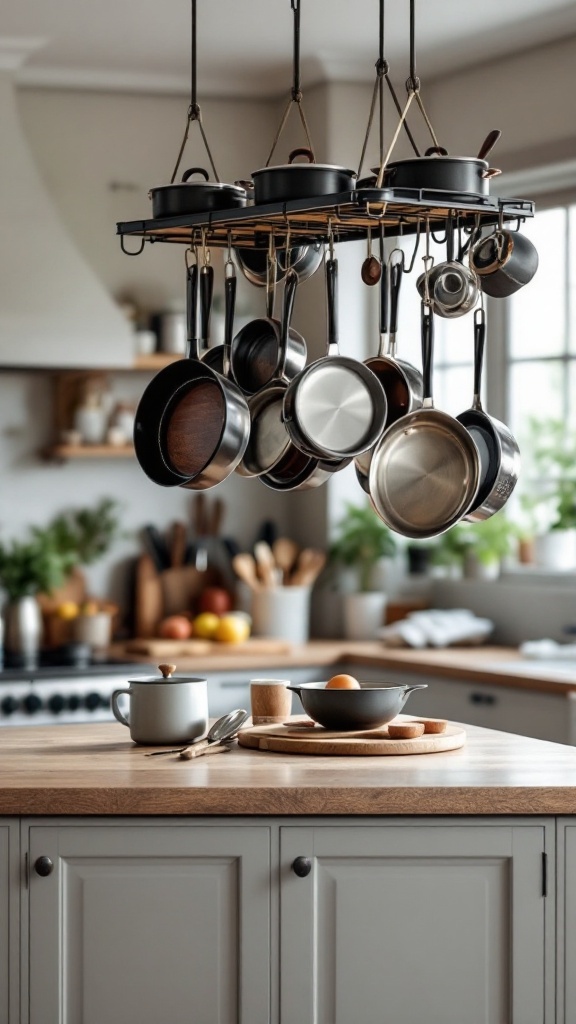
238;715;466;757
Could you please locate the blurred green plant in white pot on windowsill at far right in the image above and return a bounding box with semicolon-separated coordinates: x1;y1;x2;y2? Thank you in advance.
520;417;576;570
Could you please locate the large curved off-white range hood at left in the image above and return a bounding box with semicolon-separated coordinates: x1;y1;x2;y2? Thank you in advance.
0;39;133;368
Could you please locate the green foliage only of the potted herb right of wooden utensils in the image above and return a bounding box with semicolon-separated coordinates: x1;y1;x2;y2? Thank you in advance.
328;504;397;592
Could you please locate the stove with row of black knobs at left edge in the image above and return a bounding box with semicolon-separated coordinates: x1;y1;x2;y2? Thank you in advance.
0;662;153;727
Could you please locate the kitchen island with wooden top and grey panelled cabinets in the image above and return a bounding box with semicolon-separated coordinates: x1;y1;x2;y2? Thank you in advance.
0;723;576;1024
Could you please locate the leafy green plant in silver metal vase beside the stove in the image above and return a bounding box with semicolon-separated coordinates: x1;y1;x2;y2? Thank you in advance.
0;499;118;669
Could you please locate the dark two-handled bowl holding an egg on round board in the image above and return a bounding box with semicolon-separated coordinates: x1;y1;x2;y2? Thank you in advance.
288;683;427;732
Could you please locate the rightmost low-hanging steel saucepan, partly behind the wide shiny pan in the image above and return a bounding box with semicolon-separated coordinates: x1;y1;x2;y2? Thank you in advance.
456;309;520;522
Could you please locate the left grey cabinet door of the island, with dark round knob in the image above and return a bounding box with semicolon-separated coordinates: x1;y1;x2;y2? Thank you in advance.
30;826;270;1024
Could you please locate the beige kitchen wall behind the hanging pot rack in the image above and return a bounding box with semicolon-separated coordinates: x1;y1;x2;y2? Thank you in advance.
0;39;576;606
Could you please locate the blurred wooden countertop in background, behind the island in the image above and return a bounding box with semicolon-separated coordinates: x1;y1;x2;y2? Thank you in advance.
111;640;576;693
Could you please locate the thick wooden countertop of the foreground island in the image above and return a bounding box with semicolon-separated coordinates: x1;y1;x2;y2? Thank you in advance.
0;723;576;815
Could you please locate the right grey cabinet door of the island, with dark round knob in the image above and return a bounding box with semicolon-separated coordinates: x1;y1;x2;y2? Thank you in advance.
281;826;544;1024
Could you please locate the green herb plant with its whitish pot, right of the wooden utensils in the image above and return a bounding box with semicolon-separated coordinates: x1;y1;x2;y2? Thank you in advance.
328;504;397;640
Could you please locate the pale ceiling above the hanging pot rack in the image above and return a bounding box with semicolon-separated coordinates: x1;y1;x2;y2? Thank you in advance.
0;0;576;99
